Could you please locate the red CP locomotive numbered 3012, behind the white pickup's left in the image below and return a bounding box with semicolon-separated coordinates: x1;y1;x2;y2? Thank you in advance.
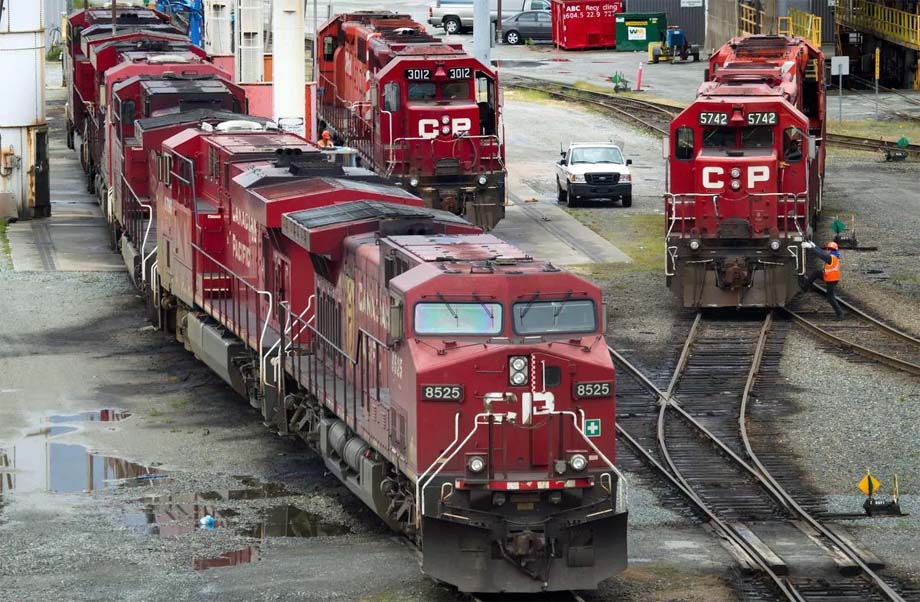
316;12;506;229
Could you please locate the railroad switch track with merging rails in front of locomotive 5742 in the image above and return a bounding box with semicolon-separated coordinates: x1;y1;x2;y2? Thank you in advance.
610;314;904;602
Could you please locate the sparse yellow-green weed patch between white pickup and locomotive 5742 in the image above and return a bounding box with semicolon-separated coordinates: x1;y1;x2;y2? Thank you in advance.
566;207;664;272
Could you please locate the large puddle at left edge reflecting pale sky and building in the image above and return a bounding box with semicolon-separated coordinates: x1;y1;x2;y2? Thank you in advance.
0;410;163;496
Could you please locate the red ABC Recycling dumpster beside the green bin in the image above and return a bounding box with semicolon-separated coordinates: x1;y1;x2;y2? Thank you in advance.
553;0;625;50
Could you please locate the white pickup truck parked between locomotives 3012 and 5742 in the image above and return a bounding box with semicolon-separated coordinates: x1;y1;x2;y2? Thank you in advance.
556;143;632;207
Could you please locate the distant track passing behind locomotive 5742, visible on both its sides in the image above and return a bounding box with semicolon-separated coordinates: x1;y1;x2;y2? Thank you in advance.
504;75;920;158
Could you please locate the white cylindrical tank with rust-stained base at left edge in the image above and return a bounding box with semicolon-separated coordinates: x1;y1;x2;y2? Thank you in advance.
0;0;51;219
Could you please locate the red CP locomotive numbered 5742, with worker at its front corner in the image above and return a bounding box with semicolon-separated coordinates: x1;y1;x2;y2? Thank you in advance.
665;36;825;307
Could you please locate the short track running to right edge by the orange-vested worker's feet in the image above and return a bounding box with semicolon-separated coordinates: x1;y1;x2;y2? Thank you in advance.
783;284;920;376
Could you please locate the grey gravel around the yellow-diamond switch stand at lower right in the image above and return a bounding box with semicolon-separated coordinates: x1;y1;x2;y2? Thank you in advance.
781;330;920;583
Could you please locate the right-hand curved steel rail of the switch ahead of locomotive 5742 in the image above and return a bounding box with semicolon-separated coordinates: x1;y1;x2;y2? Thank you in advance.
738;312;904;602
